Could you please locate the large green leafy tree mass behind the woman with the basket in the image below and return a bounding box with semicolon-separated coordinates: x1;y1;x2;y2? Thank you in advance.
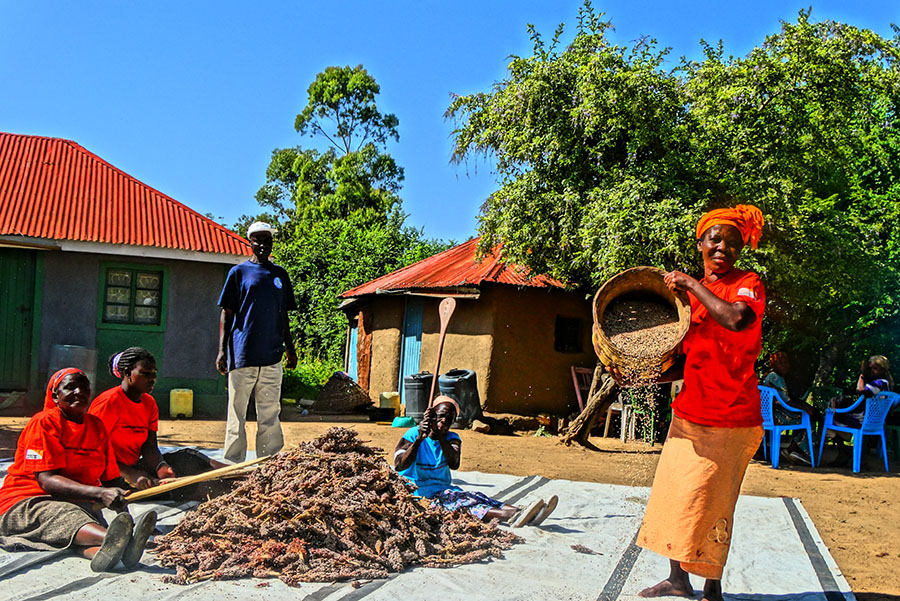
448;3;900;384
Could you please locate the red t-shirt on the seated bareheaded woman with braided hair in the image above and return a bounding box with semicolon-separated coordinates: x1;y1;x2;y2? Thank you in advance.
88;386;159;466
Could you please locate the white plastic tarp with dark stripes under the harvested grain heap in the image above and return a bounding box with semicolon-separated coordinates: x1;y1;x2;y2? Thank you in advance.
0;452;854;601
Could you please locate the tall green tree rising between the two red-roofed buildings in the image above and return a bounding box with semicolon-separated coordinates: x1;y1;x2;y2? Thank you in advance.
251;66;446;365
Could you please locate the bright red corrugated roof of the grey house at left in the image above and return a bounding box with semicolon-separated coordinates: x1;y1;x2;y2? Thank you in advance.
0;132;251;255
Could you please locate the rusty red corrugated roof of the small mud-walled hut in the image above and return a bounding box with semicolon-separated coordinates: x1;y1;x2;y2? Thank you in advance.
341;238;565;298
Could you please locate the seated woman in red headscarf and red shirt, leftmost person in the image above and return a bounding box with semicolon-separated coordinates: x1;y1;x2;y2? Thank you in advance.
0;368;156;572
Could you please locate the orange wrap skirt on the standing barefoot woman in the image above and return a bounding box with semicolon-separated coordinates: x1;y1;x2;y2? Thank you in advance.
637;416;763;580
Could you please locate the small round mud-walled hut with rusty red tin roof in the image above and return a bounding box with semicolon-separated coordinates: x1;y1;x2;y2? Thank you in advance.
341;238;597;415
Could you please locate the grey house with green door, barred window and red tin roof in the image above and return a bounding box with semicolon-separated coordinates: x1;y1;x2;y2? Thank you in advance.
0;133;251;415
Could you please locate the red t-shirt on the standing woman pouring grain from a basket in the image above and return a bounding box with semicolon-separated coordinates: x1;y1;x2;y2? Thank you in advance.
672;269;766;428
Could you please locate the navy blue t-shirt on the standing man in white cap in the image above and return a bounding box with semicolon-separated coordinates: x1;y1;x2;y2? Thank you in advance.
218;261;297;370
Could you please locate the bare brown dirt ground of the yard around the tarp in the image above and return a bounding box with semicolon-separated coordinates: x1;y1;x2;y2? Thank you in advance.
0;417;900;601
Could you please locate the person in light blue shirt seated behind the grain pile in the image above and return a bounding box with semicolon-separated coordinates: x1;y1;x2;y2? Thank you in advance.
394;396;558;528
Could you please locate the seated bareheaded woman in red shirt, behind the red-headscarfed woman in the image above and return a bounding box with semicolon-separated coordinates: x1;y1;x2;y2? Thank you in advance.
89;346;229;500
